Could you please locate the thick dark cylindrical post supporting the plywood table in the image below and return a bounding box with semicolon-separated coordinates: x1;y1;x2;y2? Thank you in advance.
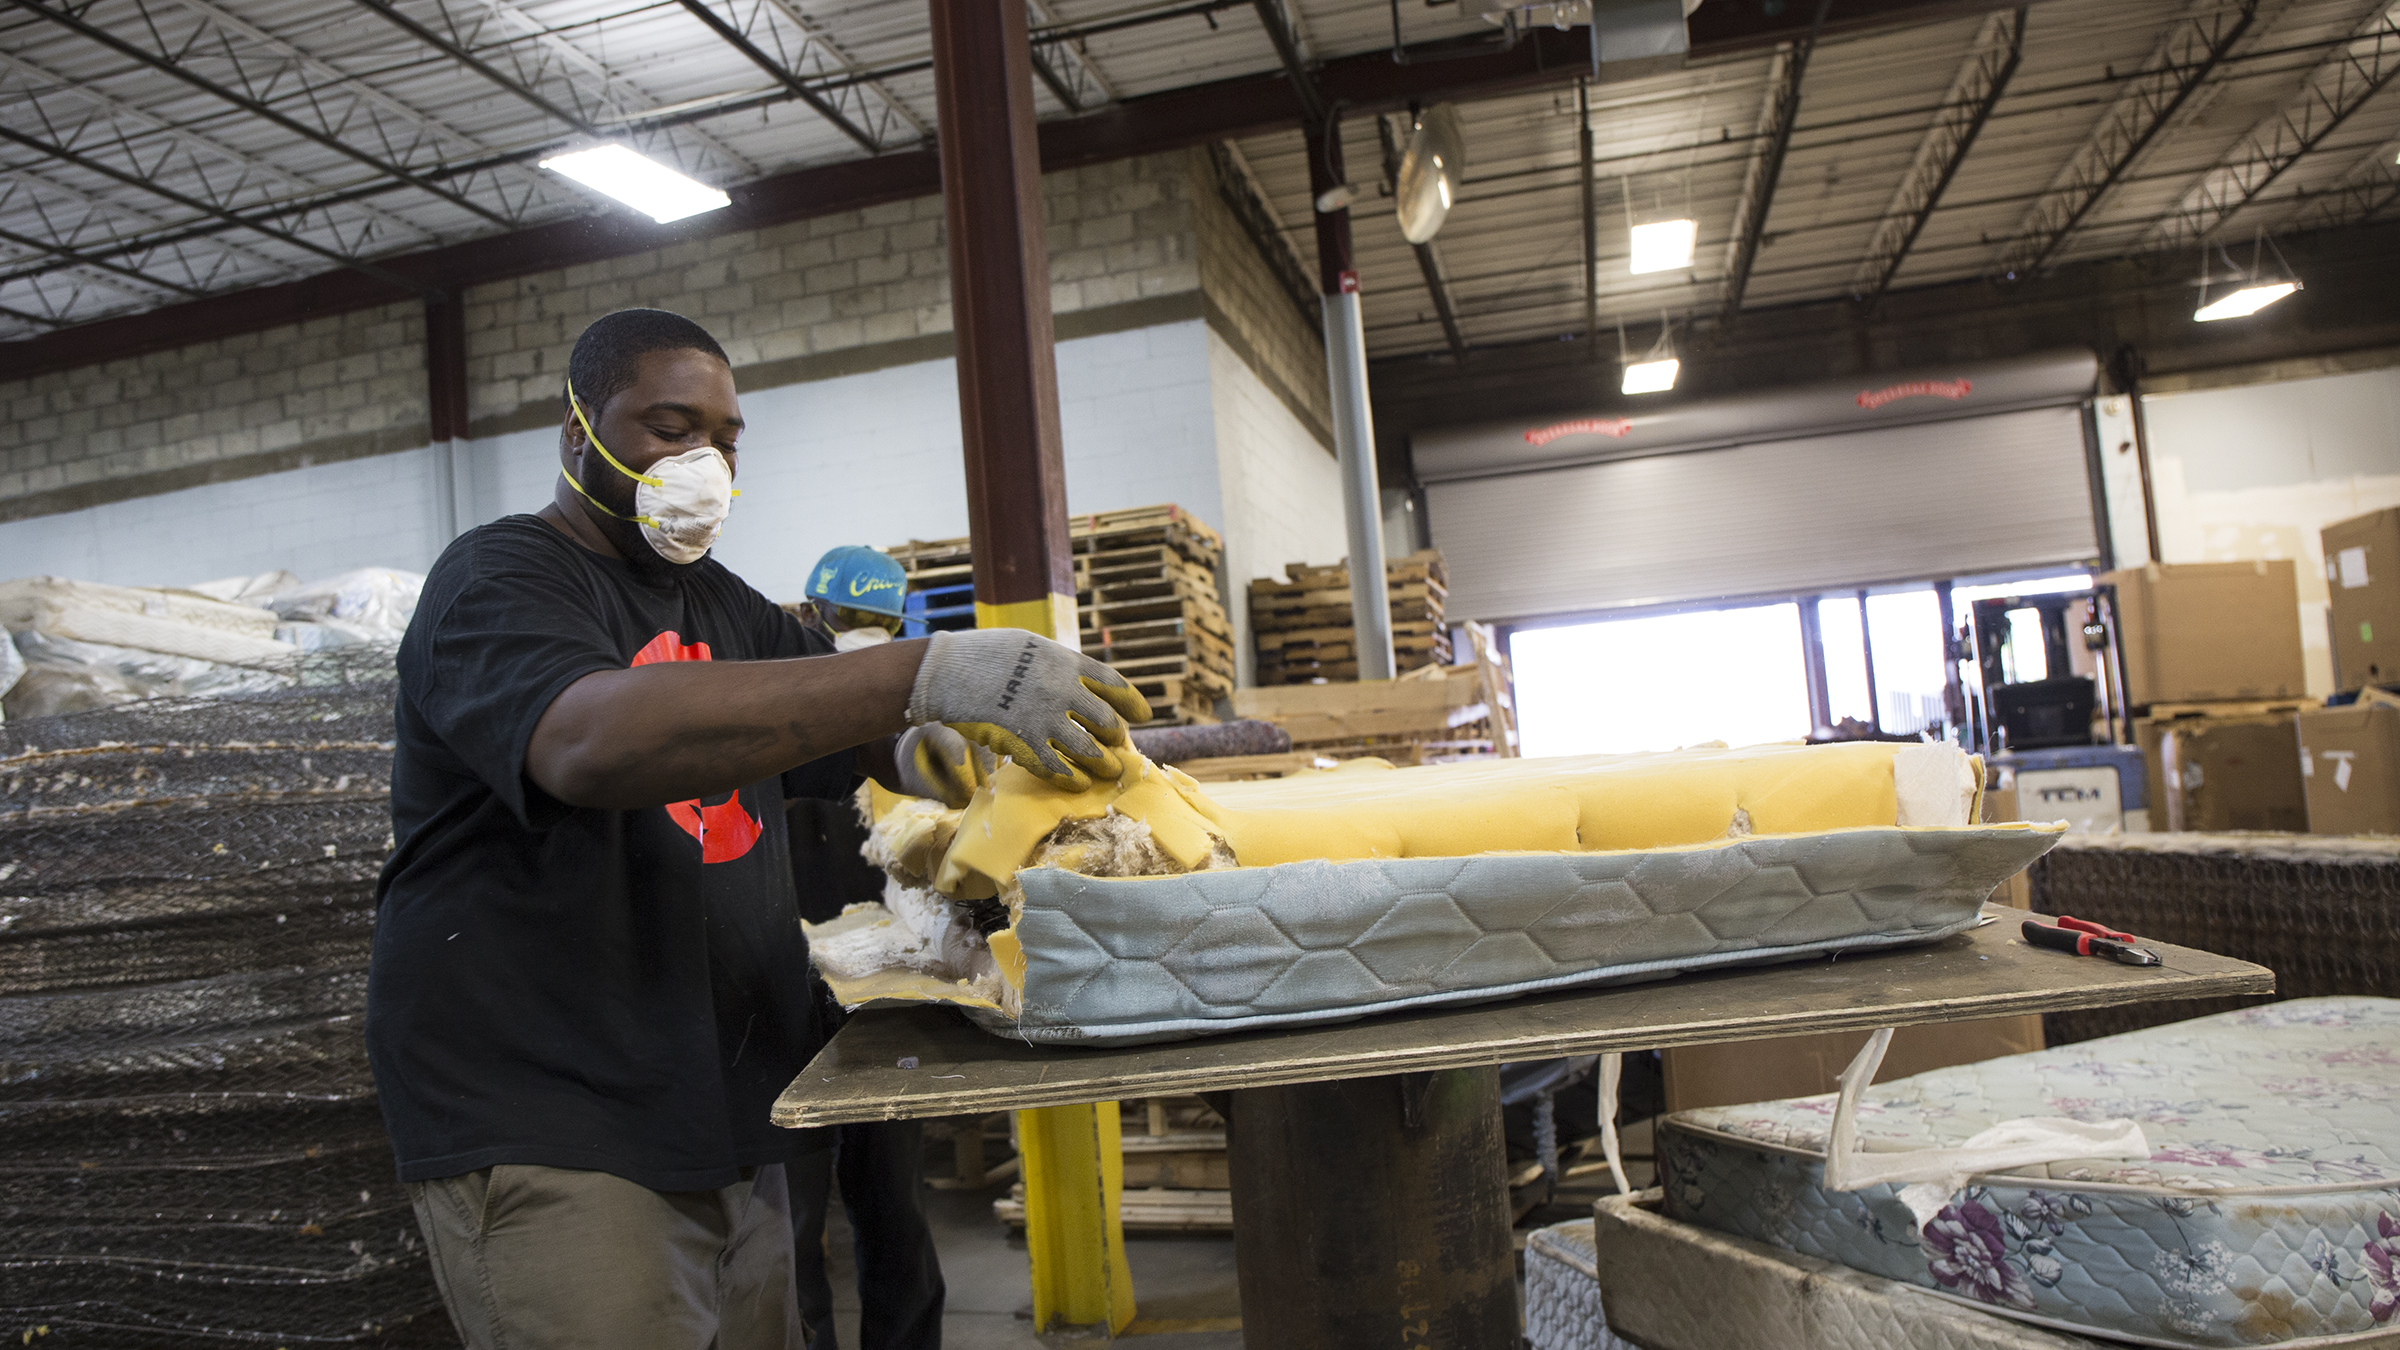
1226;1067;1519;1350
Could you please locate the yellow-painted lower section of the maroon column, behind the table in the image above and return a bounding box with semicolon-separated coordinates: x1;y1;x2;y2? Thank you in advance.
974;593;1133;1336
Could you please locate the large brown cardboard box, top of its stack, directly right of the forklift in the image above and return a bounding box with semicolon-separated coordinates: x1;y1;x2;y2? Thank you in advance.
2100;560;2309;706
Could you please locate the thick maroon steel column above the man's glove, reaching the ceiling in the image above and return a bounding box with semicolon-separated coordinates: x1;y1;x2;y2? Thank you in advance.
929;0;1075;644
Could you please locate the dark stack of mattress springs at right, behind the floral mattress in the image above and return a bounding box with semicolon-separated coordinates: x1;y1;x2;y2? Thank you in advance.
2028;834;2400;1045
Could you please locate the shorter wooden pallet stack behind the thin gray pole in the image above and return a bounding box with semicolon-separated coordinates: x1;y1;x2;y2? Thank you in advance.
1250;548;1452;685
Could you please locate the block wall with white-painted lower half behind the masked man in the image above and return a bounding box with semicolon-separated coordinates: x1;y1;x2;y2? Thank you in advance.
0;151;1346;665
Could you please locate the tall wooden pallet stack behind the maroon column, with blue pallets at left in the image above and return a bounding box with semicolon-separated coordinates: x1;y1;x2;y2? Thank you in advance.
883;507;1234;725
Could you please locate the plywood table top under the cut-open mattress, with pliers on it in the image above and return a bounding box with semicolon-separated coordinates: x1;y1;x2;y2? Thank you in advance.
773;908;2275;1127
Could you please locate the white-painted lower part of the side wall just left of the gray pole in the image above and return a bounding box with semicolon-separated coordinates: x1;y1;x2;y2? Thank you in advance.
1207;334;1349;685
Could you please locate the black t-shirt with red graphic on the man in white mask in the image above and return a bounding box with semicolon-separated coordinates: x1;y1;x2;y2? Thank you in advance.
367;516;852;1191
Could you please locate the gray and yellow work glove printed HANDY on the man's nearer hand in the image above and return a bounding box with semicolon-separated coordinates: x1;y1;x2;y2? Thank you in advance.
907;627;1150;793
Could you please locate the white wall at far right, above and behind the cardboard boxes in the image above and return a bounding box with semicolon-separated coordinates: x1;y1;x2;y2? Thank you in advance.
2119;365;2400;694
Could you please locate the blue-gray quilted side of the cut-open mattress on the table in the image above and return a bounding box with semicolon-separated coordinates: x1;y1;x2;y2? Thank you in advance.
986;826;2059;1045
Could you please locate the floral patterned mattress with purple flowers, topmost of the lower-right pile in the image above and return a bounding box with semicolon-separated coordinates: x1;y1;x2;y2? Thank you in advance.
1658;997;2400;1345
